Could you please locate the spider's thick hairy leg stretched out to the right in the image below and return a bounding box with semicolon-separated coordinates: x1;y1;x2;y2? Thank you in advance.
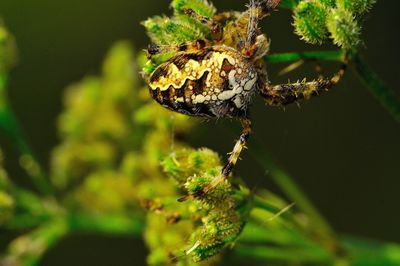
260;56;348;106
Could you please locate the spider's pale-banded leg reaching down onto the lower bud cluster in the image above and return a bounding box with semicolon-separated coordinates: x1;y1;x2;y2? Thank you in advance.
178;117;251;202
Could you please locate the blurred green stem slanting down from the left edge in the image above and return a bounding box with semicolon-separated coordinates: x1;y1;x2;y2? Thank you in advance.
0;73;52;195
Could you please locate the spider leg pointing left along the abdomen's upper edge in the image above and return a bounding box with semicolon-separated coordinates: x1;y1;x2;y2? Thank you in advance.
146;40;209;59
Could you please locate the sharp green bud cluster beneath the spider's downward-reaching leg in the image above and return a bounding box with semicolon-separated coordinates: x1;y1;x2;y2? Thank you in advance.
157;149;250;262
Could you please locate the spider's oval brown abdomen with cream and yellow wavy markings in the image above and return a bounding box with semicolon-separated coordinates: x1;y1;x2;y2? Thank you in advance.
148;46;257;117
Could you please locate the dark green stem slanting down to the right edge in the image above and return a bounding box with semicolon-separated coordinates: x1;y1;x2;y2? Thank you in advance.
354;55;400;122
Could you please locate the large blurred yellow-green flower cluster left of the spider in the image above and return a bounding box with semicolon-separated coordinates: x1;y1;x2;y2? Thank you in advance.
51;42;190;216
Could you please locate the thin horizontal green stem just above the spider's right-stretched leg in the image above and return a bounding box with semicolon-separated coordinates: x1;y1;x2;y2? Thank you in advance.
266;50;344;63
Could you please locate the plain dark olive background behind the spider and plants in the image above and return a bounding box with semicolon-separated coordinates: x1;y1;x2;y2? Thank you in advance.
0;0;400;265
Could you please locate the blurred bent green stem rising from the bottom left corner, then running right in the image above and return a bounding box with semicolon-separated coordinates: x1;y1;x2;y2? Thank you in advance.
0;211;144;266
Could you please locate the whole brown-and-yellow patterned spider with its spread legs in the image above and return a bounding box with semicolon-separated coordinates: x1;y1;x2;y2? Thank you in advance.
143;0;346;201
